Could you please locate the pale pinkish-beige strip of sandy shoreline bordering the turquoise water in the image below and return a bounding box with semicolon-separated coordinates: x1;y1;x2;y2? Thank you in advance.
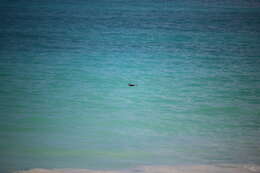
14;164;260;173
